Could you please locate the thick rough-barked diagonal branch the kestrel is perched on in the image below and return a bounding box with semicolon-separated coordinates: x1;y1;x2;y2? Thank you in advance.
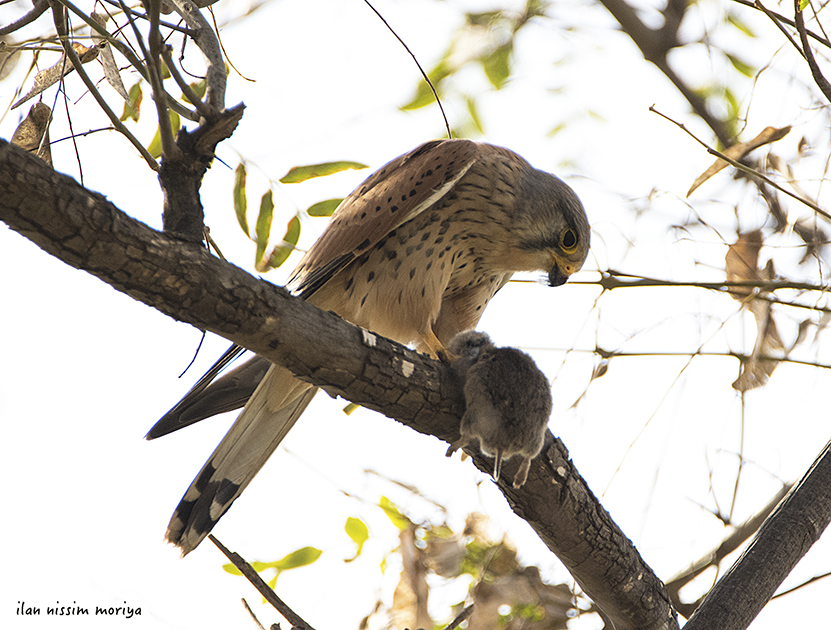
0;140;678;630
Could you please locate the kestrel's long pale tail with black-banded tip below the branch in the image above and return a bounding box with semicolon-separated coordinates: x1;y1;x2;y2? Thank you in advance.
166;366;317;555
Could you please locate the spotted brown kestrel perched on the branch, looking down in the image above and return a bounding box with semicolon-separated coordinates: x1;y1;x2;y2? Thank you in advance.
147;140;590;555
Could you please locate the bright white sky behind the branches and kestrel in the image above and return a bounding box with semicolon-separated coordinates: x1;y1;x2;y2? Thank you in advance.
0;0;831;630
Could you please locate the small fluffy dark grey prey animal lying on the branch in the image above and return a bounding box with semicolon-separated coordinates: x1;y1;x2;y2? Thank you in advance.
447;330;551;488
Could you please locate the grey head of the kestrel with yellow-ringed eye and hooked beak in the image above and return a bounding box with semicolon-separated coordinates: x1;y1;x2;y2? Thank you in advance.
511;169;591;287
